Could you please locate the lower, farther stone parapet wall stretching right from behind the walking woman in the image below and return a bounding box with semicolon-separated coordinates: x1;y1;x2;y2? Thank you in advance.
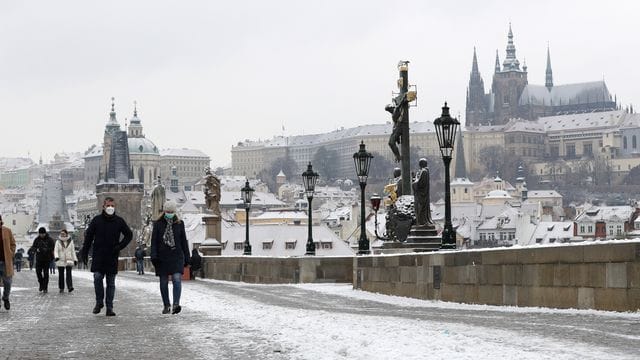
202;256;353;284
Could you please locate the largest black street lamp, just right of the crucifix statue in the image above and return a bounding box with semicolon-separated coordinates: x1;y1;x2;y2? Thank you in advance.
433;102;460;249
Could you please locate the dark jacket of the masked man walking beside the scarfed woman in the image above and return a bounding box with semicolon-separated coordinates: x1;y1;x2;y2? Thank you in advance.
80;211;133;274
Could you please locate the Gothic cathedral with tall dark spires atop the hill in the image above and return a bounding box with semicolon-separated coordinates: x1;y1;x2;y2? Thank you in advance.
466;25;616;126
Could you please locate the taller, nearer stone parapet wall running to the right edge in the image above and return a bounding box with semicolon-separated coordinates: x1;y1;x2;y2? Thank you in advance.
353;241;640;311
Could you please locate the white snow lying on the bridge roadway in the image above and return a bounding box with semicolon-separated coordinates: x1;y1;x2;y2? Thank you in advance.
74;272;640;360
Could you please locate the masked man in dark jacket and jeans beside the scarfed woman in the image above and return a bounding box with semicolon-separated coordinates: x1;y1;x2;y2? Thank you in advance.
81;197;133;316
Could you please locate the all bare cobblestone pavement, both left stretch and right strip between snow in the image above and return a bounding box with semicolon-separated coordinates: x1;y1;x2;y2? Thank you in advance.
0;270;640;359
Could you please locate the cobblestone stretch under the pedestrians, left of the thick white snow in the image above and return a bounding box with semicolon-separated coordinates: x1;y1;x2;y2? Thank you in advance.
0;270;285;359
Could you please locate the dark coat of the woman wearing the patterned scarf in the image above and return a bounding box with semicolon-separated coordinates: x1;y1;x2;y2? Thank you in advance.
151;218;189;276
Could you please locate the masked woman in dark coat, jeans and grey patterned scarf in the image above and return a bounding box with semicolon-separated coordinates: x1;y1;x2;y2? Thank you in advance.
151;201;189;314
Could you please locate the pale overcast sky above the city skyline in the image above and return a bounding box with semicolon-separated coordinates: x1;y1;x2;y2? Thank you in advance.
0;0;640;166
